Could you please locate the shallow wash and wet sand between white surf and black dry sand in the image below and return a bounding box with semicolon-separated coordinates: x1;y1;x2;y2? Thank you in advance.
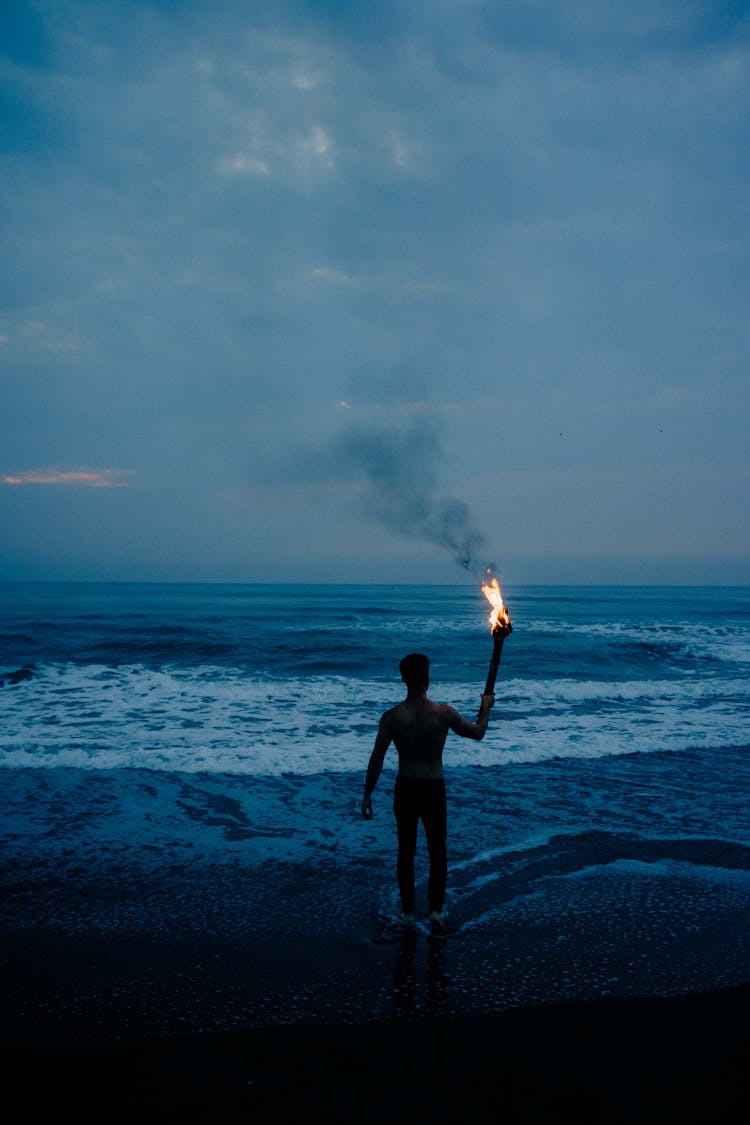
5;758;750;1047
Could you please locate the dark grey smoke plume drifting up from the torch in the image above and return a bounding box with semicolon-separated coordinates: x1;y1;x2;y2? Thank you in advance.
340;424;485;570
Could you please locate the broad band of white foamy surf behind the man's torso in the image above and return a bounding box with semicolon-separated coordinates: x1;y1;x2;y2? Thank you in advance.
0;664;750;775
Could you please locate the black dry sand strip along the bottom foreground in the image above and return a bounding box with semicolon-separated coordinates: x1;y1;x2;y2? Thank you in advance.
4;986;750;1123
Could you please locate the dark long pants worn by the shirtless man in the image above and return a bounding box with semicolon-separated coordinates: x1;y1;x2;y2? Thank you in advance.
394;774;448;914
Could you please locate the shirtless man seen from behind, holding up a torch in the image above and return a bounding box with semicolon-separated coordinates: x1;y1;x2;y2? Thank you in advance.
362;653;495;935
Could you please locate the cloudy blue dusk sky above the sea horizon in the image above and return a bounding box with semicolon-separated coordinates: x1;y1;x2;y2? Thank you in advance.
0;0;750;586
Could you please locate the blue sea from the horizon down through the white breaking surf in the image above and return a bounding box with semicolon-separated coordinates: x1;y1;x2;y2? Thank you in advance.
0;584;750;775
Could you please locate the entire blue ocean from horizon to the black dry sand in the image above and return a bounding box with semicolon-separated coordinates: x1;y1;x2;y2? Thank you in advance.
0;583;750;1038
